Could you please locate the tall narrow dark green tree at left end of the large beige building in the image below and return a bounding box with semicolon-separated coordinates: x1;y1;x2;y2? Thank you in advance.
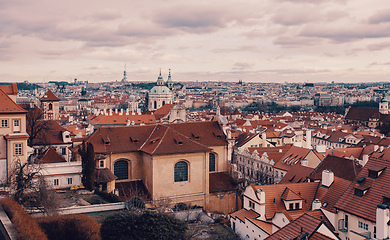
79;141;96;190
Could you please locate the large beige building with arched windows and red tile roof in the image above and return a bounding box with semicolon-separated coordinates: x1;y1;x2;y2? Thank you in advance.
83;122;238;213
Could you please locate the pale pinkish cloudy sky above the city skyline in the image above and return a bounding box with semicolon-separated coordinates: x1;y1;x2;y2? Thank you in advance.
0;0;390;83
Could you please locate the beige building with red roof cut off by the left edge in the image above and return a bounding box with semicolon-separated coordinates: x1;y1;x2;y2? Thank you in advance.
0;89;28;184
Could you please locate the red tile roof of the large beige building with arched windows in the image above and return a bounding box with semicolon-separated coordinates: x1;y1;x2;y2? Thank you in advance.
88;122;227;155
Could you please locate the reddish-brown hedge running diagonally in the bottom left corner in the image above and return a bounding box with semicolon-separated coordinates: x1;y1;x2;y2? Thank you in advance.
0;197;48;240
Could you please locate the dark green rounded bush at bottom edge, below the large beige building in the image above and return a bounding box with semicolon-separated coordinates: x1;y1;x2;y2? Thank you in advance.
100;212;187;240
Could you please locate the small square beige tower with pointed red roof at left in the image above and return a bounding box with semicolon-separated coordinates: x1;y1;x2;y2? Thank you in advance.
40;90;60;120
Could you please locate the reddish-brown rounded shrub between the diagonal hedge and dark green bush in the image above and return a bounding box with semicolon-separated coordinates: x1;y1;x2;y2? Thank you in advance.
37;214;100;240
